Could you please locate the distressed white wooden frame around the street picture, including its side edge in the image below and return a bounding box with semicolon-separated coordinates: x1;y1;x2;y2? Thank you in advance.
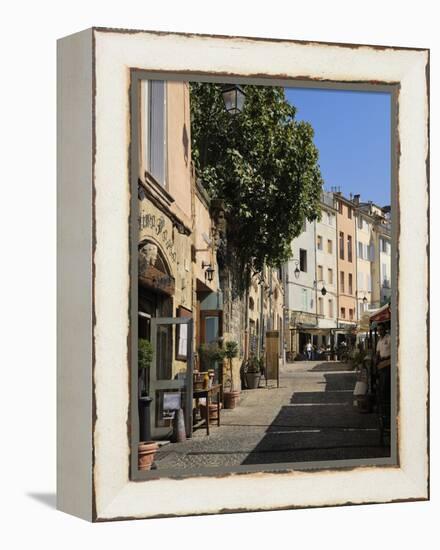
57;28;429;521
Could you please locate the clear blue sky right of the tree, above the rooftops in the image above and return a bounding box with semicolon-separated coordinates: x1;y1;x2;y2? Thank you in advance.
286;88;391;206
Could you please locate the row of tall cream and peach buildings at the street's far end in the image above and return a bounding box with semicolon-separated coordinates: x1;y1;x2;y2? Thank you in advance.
284;192;391;360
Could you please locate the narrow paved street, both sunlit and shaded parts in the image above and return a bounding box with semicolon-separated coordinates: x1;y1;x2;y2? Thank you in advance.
156;361;389;470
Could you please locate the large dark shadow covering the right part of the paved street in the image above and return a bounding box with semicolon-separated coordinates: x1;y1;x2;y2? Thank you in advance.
242;373;390;464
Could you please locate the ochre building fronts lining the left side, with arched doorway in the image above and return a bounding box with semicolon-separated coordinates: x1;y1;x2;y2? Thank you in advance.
137;80;284;438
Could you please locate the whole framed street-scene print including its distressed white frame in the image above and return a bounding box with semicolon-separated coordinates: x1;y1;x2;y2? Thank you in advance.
57;28;429;521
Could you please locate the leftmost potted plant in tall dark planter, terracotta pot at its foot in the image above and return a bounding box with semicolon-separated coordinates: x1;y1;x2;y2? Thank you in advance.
138;338;159;470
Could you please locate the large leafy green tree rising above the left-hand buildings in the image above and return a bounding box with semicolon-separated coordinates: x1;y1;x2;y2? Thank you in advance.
191;83;322;290
